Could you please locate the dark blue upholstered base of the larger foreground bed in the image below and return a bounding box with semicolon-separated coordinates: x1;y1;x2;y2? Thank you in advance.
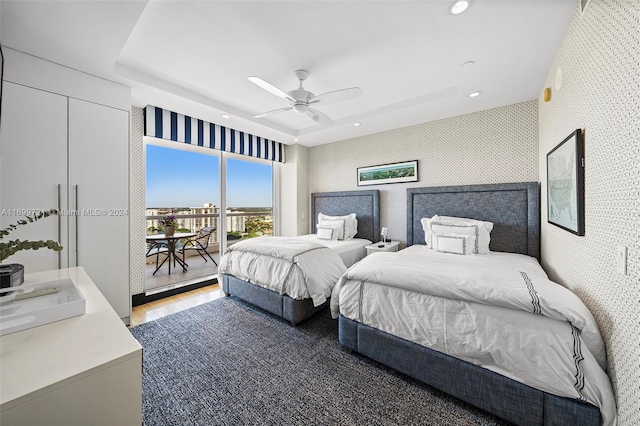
338;315;601;426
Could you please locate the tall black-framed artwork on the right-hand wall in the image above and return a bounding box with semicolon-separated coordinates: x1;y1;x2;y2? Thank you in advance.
547;129;584;235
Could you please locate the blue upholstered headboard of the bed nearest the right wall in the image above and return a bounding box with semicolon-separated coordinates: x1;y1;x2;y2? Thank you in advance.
407;182;540;260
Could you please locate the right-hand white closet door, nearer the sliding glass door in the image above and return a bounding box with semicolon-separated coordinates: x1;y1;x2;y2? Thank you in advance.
69;99;130;320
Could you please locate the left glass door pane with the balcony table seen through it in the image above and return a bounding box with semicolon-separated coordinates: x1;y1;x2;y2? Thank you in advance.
145;142;221;292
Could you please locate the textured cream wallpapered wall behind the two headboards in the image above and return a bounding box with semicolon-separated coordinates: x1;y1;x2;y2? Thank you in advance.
307;100;539;244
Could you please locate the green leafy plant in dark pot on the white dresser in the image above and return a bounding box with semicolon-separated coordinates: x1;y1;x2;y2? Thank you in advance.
0;209;62;288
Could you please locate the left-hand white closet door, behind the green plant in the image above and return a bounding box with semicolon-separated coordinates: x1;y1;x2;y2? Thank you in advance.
0;82;67;273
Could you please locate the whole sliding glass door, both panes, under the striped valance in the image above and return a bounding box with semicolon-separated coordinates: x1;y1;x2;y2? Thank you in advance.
145;138;274;293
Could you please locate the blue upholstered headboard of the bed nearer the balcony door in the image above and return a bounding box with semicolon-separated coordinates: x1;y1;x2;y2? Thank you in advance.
310;189;380;243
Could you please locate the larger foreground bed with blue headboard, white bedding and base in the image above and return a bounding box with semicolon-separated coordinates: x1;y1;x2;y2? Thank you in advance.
331;182;616;426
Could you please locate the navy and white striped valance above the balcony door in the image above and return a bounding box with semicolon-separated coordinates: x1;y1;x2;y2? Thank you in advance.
144;105;284;163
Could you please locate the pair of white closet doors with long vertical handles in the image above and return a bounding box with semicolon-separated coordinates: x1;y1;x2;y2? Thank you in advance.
0;81;131;322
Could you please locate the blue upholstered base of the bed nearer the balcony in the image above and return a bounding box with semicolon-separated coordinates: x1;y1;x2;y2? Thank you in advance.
219;274;329;325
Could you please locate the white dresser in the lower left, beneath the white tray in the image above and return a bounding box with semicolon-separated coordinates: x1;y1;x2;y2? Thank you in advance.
0;267;142;426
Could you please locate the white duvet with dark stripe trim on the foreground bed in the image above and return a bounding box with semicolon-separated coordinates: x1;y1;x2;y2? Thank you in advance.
331;246;616;425
